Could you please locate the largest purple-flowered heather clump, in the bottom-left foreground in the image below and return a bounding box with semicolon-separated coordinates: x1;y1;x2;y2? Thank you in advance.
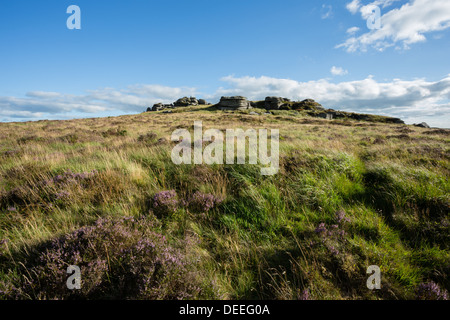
0;218;211;299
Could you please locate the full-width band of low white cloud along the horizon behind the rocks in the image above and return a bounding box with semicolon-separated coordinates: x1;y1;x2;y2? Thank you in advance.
0;74;450;128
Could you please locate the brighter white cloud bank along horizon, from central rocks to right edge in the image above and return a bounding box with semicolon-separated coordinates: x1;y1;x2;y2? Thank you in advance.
215;74;450;128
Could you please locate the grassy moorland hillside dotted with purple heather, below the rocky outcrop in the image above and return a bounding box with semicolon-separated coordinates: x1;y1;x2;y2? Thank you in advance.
0;107;450;299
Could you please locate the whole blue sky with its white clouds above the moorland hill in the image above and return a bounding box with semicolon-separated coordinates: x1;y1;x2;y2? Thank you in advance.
0;0;450;127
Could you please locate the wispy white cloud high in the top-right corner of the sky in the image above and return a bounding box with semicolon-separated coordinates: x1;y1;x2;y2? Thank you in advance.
336;0;450;52
